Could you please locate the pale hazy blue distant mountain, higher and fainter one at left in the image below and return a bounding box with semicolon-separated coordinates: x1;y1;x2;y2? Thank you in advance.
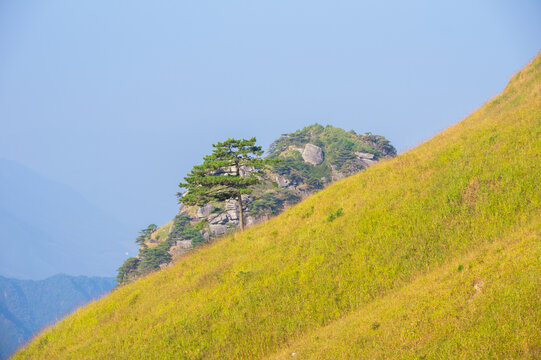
0;159;134;279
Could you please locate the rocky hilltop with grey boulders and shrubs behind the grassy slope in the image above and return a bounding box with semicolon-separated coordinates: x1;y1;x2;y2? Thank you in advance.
118;124;396;283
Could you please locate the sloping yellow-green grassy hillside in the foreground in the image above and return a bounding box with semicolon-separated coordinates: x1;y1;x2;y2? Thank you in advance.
15;56;541;359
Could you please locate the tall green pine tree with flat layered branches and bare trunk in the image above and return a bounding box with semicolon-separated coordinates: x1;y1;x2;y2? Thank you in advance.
178;137;276;230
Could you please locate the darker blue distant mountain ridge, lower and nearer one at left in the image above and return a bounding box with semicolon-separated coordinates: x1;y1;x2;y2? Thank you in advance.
0;275;115;359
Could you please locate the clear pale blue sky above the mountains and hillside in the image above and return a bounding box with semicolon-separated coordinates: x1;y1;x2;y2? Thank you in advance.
0;0;541;233
